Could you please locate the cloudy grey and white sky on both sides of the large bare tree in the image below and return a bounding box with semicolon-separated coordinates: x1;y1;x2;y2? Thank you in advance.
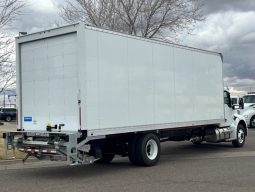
7;0;255;94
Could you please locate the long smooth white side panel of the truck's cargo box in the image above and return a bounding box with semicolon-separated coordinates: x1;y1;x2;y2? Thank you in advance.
81;29;224;134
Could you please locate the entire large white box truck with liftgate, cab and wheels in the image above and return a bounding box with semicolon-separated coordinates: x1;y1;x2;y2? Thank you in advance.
5;24;247;166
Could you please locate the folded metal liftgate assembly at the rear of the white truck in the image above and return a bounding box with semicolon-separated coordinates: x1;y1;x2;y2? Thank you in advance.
4;131;105;165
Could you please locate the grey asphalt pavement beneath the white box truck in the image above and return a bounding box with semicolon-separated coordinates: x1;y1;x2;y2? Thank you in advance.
0;129;255;192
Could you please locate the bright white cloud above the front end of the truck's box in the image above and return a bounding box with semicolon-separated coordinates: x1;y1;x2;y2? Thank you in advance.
184;11;255;51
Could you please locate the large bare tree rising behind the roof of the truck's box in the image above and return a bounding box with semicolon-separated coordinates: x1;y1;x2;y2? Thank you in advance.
60;0;204;41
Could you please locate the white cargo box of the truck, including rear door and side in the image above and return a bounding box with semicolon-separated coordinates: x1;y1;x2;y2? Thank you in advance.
18;26;224;135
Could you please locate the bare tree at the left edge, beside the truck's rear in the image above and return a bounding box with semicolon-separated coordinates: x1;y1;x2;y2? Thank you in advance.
0;0;24;93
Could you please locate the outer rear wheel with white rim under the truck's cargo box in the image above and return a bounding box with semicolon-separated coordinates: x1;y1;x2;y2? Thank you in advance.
136;133;161;166
